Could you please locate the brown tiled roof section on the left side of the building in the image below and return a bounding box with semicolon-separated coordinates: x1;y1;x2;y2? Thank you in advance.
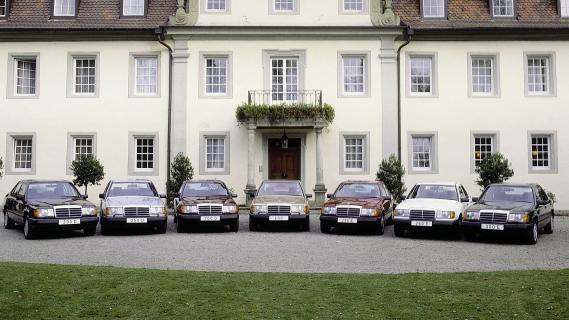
0;0;176;30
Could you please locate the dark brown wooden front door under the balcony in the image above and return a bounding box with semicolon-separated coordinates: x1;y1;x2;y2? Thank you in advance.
269;139;301;180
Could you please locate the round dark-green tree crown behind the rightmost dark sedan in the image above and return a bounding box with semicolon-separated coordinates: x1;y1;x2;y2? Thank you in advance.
476;153;514;189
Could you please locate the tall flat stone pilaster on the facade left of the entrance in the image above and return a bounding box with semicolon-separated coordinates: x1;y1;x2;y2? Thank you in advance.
171;37;190;159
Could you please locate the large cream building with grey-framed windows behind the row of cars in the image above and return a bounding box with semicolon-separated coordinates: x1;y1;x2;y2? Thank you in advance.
0;0;569;209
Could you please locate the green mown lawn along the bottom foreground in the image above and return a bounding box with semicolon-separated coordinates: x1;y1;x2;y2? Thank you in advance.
0;263;569;319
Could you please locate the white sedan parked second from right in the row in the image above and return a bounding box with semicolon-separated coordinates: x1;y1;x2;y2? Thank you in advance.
393;182;471;237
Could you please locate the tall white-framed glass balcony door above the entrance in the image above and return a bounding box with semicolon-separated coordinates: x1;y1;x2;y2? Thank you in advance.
271;58;299;103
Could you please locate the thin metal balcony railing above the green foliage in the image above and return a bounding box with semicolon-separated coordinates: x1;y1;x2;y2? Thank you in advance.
248;90;322;107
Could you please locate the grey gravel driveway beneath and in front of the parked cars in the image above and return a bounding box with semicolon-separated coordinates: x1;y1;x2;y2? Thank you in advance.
0;215;569;273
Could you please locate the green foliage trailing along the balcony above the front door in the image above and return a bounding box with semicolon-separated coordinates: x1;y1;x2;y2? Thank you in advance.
235;103;335;124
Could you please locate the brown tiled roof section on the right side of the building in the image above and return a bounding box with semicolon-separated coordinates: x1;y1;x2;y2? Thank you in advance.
394;0;569;30
